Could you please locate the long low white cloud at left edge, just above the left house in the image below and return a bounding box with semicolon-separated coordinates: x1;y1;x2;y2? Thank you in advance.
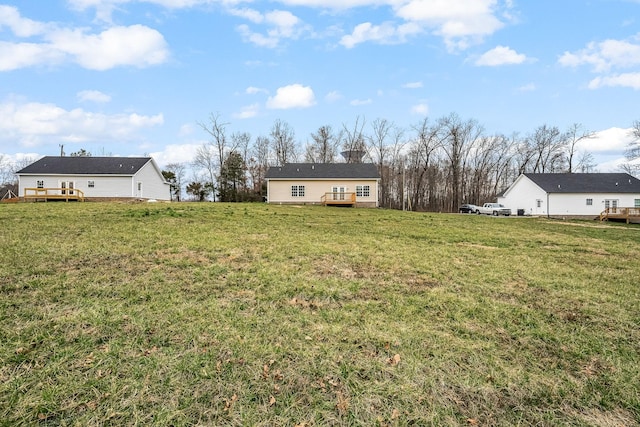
0;101;164;147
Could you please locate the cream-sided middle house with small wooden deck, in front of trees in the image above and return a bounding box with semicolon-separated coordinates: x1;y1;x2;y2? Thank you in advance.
265;163;380;208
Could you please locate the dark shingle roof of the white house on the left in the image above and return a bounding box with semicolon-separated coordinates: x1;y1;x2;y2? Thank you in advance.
17;156;151;175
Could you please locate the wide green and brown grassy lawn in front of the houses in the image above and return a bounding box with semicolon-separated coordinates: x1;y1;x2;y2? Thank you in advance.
0;203;640;427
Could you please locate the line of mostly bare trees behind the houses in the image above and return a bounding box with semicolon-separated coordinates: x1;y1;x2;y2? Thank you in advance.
0;113;640;212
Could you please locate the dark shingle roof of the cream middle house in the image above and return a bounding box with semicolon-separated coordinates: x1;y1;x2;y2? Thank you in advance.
266;163;380;179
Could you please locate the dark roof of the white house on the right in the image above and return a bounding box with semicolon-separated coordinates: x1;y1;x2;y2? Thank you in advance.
524;173;640;194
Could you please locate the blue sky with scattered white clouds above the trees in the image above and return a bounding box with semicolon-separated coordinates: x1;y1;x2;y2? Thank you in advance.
0;0;640;172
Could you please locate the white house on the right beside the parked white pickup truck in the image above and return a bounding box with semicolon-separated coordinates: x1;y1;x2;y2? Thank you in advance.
498;173;640;217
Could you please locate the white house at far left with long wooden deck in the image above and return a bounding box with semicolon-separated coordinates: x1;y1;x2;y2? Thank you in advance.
16;156;171;200
